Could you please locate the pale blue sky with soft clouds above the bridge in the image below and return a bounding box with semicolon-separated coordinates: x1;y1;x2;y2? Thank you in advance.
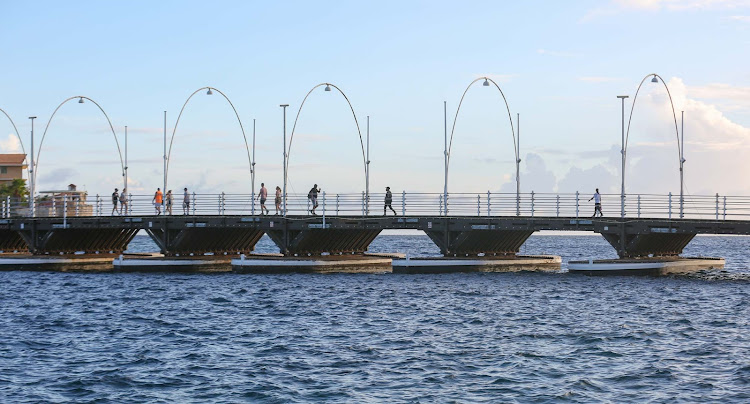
0;0;750;200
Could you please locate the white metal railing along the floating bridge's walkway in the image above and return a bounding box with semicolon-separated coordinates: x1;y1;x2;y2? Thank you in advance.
8;191;750;220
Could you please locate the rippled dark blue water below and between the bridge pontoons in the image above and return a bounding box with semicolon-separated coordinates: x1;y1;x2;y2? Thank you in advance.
0;236;750;403
